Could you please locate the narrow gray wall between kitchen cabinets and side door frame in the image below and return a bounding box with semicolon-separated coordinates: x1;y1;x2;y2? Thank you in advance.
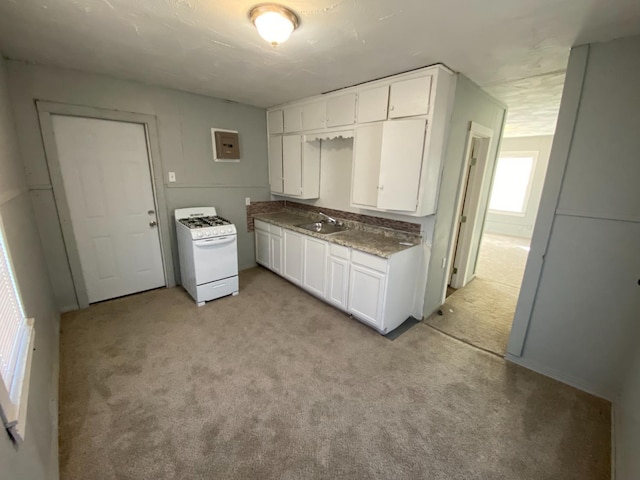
423;75;506;317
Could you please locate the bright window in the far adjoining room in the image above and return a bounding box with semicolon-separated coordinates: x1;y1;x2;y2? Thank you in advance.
489;152;537;215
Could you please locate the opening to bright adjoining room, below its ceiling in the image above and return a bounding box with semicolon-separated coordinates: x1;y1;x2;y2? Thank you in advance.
428;135;553;355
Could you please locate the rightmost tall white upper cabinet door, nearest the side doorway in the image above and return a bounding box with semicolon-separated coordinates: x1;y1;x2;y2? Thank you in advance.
378;118;426;212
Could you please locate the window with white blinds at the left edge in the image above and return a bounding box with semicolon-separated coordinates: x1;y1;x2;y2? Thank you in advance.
0;214;34;440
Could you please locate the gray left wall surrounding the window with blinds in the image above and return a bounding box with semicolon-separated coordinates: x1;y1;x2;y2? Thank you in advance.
0;57;60;480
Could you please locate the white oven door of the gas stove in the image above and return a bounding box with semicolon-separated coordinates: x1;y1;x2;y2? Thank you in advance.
193;235;238;285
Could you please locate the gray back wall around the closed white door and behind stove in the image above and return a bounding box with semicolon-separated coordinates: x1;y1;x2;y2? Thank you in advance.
8;61;270;310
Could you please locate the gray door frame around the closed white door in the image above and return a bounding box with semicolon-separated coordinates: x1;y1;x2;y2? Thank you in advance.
36;100;176;308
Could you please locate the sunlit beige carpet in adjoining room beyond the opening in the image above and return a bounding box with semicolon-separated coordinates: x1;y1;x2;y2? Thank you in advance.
426;233;529;355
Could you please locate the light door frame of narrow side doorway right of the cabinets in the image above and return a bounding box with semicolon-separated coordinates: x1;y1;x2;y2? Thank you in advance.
445;122;494;290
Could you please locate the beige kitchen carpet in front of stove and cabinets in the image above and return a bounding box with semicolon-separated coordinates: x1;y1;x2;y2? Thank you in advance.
60;268;610;480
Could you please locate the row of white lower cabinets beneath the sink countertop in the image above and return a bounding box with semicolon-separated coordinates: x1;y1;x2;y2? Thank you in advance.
255;225;421;334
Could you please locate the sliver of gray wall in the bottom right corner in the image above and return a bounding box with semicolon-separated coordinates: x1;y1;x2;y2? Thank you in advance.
614;346;640;480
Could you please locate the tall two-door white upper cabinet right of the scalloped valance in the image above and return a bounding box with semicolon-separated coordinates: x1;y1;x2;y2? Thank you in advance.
351;118;426;212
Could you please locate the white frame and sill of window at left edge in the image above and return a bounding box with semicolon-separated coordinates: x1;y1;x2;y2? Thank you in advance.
0;216;35;443
